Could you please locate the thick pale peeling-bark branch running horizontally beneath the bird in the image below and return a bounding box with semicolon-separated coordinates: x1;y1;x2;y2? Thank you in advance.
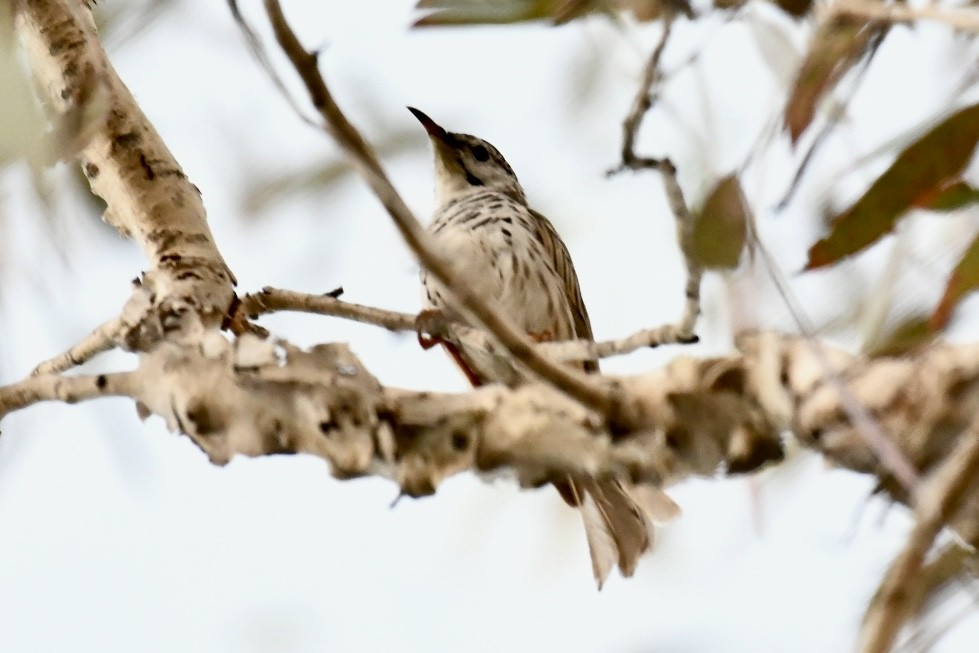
0;331;979;520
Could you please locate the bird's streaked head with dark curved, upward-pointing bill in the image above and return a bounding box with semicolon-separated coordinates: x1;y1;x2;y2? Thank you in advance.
408;107;527;206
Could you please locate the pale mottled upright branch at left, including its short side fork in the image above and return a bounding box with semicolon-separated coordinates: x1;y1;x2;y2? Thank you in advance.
13;0;234;370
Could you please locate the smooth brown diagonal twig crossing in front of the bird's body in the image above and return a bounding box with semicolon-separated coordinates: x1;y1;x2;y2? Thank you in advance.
233;0;635;421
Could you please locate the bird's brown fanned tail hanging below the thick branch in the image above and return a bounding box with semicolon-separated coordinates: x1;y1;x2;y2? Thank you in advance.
570;479;680;589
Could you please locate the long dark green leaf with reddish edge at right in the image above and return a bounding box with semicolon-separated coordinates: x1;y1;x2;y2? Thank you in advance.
805;104;979;270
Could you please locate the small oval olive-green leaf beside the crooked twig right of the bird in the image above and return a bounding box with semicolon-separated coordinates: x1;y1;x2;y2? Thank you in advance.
690;175;749;269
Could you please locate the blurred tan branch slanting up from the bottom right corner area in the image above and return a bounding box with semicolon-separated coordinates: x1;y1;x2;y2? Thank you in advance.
859;418;979;653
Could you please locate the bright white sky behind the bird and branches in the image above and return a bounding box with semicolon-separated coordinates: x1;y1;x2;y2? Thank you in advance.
0;0;979;653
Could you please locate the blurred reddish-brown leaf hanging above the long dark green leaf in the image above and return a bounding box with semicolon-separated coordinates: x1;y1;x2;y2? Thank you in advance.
785;12;885;143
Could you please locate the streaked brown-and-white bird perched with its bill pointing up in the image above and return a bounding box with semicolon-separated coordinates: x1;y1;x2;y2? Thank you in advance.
408;107;676;589
